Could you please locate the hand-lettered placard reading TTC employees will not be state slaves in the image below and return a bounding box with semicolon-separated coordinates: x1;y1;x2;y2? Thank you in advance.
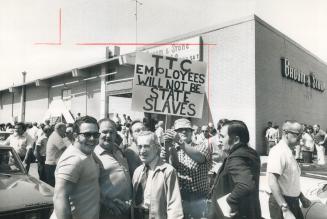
132;53;206;118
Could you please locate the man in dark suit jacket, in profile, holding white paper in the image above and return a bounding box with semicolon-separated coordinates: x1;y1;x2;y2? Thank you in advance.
211;120;261;219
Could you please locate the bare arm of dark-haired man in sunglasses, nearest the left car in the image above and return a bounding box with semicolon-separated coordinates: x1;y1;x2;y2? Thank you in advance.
53;177;75;219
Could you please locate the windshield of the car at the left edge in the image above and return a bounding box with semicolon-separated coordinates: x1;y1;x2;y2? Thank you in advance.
0;148;24;175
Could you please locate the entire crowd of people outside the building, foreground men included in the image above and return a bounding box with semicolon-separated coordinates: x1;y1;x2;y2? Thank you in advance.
0;114;326;219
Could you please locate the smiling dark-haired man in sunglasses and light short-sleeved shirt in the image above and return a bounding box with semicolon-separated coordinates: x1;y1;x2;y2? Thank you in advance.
51;116;100;219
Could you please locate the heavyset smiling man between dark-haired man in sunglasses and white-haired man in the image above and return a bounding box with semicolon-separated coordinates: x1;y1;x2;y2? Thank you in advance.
94;119;132;219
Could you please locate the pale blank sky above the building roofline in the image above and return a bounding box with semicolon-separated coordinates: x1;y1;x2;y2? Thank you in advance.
0;0;327;89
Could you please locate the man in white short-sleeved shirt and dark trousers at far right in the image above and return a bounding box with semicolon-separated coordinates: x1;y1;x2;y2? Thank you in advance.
267;120;311;219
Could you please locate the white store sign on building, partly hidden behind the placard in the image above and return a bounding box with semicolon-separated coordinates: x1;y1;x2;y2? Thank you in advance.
144;37;202;61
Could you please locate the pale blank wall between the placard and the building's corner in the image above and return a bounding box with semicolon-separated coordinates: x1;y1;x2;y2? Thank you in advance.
202;20;256;148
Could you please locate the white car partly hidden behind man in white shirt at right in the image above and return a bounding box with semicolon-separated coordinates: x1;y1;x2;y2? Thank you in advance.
259;157;327;219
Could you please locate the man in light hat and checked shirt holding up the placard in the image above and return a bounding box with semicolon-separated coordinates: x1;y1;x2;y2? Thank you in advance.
163;118;211;218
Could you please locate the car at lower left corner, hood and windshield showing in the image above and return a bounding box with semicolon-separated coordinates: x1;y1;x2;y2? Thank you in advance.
0;145;53;219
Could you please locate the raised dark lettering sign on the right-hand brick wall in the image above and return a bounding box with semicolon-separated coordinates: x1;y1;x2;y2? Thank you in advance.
281;58;326;92
